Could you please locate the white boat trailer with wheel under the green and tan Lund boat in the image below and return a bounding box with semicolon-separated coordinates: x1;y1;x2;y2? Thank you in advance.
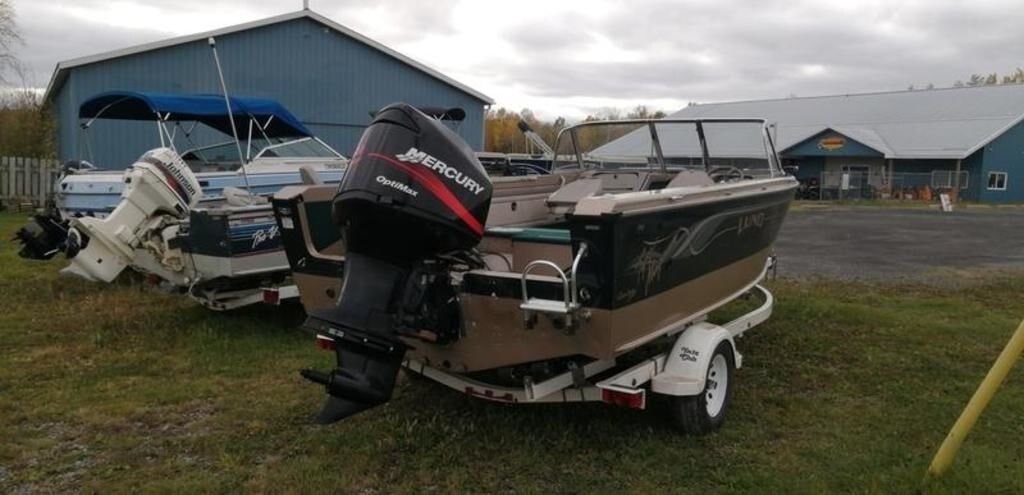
317;257;775;434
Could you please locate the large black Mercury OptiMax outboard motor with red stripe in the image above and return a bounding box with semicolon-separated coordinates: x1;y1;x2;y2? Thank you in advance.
302;104;493;423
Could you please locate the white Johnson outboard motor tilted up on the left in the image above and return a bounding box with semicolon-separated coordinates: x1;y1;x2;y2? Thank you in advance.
61;148;202;282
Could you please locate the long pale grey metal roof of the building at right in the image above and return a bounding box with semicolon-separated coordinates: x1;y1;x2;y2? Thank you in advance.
672;85;1024;159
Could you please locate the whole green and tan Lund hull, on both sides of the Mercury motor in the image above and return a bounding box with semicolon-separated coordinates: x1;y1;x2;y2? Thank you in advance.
274;179;796;372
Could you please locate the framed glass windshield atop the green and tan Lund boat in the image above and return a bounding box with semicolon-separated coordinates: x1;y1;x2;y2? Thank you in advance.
553;119;779;177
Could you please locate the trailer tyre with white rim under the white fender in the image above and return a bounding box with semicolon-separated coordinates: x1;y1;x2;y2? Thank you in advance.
671;341;736;435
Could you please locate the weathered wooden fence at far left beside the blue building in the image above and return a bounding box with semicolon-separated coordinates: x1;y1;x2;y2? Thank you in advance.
0;157;60;209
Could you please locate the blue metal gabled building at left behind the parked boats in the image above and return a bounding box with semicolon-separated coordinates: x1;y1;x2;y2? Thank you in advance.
45;10;494;168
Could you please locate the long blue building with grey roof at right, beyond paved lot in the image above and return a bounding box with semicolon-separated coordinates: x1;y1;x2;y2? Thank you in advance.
673;85;1024;203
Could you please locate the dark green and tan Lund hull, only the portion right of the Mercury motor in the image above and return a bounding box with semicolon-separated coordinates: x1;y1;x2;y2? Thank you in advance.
428;185;794;372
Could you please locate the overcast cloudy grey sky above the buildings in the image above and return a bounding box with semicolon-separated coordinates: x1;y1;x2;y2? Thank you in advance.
6;0;1024;118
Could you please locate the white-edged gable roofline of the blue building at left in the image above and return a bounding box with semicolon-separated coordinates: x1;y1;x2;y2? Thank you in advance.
44;9;495;105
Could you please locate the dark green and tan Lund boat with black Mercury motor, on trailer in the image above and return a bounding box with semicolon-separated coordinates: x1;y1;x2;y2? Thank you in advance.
273;105;797;431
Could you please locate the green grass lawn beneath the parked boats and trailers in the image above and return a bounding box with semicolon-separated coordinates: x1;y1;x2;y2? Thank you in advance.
0;213;1024;494
